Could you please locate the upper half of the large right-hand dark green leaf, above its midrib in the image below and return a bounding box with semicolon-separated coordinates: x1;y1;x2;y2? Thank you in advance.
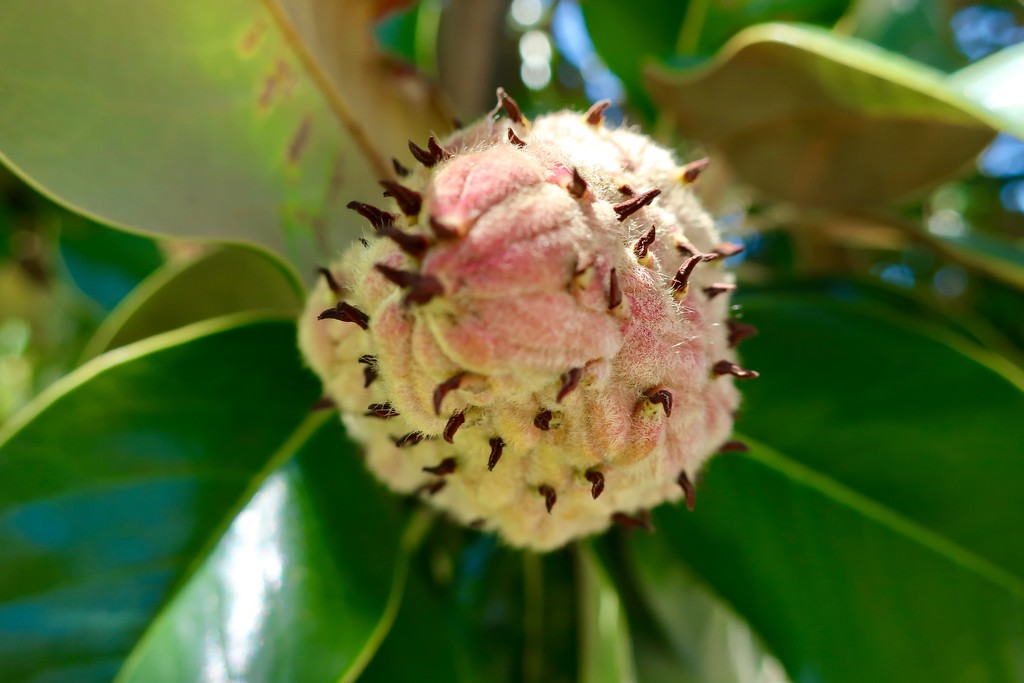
738;293;1024;571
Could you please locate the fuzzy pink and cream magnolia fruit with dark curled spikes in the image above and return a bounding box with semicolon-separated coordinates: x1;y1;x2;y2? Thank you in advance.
299;90;757;550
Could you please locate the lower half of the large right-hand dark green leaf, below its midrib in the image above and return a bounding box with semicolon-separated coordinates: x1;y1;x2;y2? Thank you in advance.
636;444;1024;683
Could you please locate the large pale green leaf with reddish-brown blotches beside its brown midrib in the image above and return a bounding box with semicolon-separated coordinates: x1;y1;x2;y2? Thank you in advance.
0;0;450;272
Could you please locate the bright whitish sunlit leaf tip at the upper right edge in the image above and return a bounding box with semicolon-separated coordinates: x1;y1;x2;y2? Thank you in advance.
949;43;1024;138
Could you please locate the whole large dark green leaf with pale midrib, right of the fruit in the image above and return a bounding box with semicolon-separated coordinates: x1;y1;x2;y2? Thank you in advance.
636;293;1024;683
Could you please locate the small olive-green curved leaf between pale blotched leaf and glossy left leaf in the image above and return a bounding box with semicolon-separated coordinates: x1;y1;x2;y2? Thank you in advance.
83;247;303;359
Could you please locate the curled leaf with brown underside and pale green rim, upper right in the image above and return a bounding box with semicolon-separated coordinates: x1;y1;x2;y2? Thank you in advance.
648;24;998;208
